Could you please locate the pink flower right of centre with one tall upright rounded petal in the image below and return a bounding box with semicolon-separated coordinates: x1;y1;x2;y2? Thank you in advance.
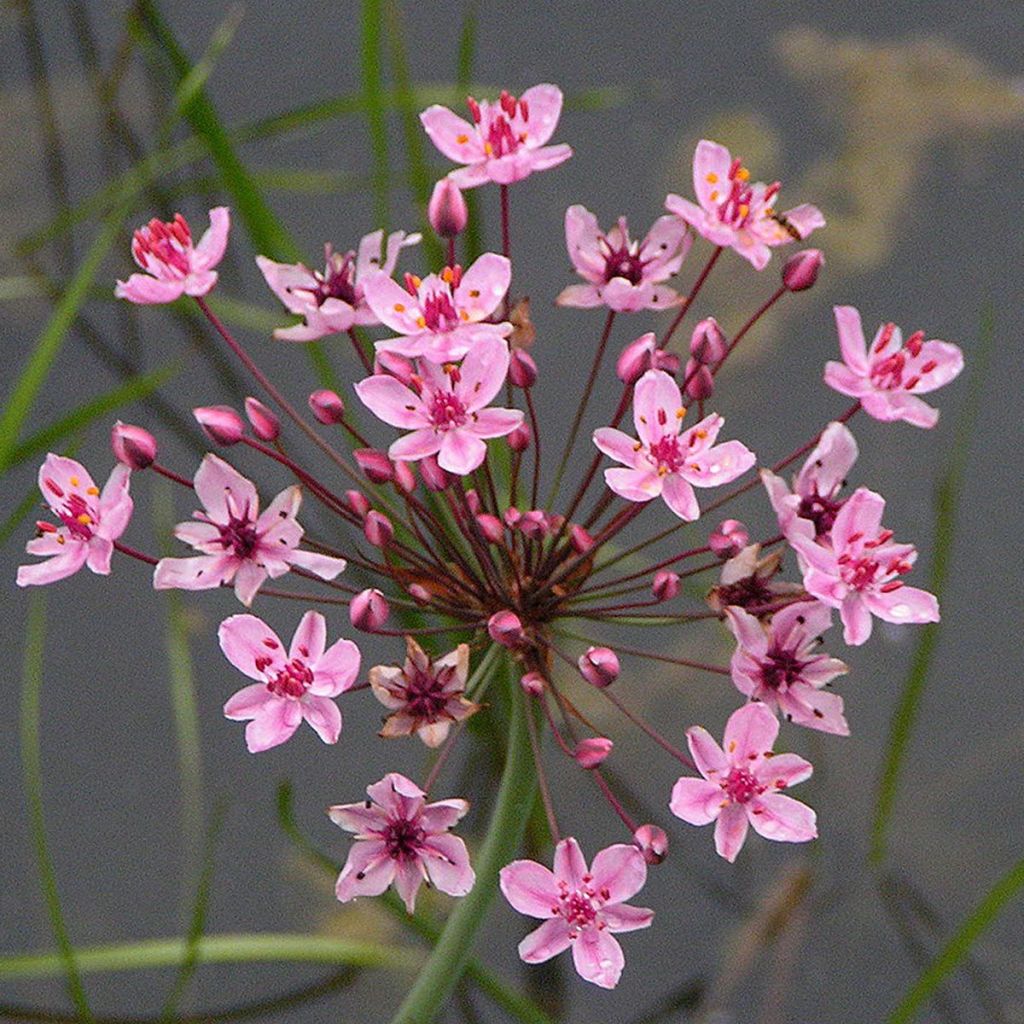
594;370;756;521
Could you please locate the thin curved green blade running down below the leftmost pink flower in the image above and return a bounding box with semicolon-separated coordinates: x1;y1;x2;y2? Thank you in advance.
20;591;92;1024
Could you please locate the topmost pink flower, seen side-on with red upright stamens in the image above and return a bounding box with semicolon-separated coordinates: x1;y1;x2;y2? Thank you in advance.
420;85;572;188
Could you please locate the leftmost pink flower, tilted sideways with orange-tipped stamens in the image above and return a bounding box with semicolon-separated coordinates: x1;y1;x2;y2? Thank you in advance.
17;452;132;587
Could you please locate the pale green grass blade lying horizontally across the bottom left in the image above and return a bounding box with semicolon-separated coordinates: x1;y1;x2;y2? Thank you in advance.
0;932;423;981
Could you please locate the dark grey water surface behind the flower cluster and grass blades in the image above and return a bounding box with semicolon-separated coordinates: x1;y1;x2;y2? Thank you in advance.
0;2;1024;1024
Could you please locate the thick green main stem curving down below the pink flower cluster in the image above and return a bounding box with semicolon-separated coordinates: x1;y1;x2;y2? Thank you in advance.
391;666;537;1024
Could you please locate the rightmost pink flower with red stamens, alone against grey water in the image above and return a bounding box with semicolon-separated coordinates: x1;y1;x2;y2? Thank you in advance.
825;306;964;427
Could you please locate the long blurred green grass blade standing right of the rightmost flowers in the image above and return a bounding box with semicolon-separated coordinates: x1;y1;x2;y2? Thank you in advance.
868;310;995;865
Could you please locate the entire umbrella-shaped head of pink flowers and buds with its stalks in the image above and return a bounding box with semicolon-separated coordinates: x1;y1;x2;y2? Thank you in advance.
17;85;962;999
